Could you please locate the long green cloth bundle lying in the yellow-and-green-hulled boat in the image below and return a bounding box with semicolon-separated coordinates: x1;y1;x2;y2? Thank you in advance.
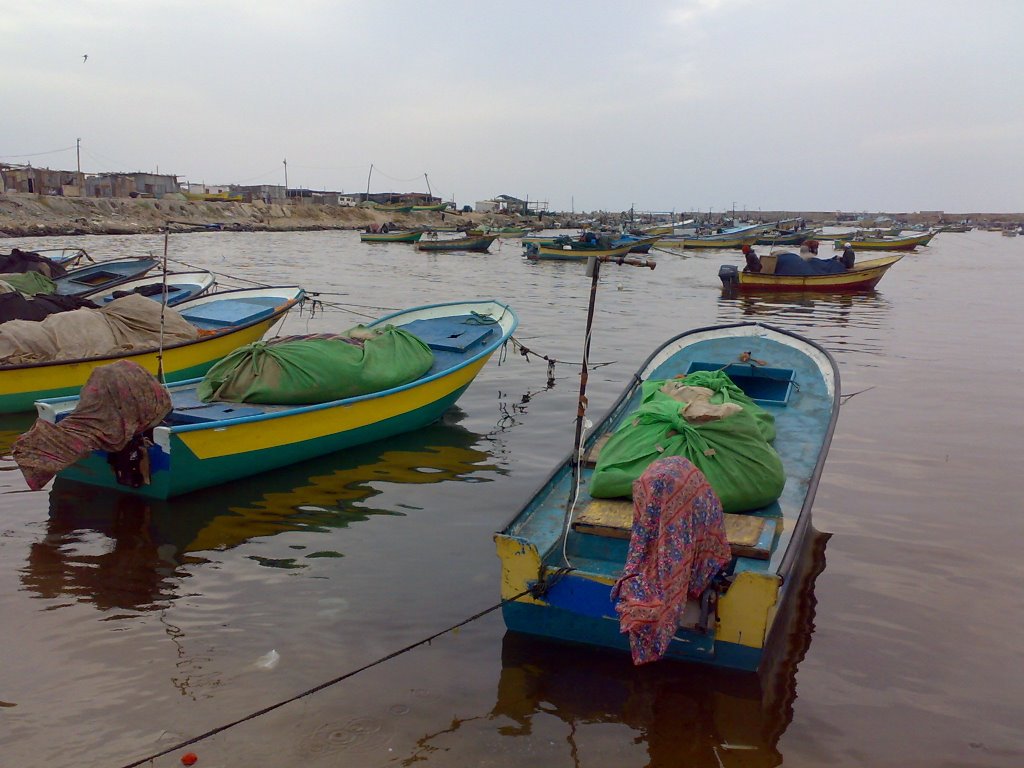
197;326;434;406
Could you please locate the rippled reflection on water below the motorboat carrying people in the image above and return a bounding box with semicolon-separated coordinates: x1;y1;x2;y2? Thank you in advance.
718;291;892;354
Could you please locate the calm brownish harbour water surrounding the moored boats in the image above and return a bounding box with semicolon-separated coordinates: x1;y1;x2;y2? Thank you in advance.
0;231;1024;768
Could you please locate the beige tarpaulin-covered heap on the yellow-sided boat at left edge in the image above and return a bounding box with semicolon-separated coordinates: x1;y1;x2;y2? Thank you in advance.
0;294;199;365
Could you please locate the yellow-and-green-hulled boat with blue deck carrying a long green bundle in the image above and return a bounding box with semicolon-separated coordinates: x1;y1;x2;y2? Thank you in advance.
38;301;518;499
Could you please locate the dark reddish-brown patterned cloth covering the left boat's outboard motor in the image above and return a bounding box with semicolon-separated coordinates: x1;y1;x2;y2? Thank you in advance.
11;360;171;490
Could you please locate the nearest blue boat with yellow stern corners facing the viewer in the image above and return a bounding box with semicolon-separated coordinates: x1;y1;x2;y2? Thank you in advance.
495;323;840;671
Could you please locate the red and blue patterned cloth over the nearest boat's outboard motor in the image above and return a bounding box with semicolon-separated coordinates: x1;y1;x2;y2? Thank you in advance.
611;456;732;665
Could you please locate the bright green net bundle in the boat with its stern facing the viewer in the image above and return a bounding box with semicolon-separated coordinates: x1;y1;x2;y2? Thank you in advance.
590;371;785;512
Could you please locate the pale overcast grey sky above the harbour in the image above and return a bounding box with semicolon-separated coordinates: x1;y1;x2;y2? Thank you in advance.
0;0;1024;213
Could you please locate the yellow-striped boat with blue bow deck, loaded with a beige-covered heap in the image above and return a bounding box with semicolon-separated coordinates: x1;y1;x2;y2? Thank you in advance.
0;286;305;414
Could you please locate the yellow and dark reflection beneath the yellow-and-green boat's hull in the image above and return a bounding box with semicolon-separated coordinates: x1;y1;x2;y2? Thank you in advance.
22;409;505;610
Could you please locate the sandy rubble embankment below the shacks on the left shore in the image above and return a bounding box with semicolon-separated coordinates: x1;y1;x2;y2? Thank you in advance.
0;193;506;238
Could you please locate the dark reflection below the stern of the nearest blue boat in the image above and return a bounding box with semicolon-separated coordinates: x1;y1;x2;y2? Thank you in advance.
481;531;828;768
